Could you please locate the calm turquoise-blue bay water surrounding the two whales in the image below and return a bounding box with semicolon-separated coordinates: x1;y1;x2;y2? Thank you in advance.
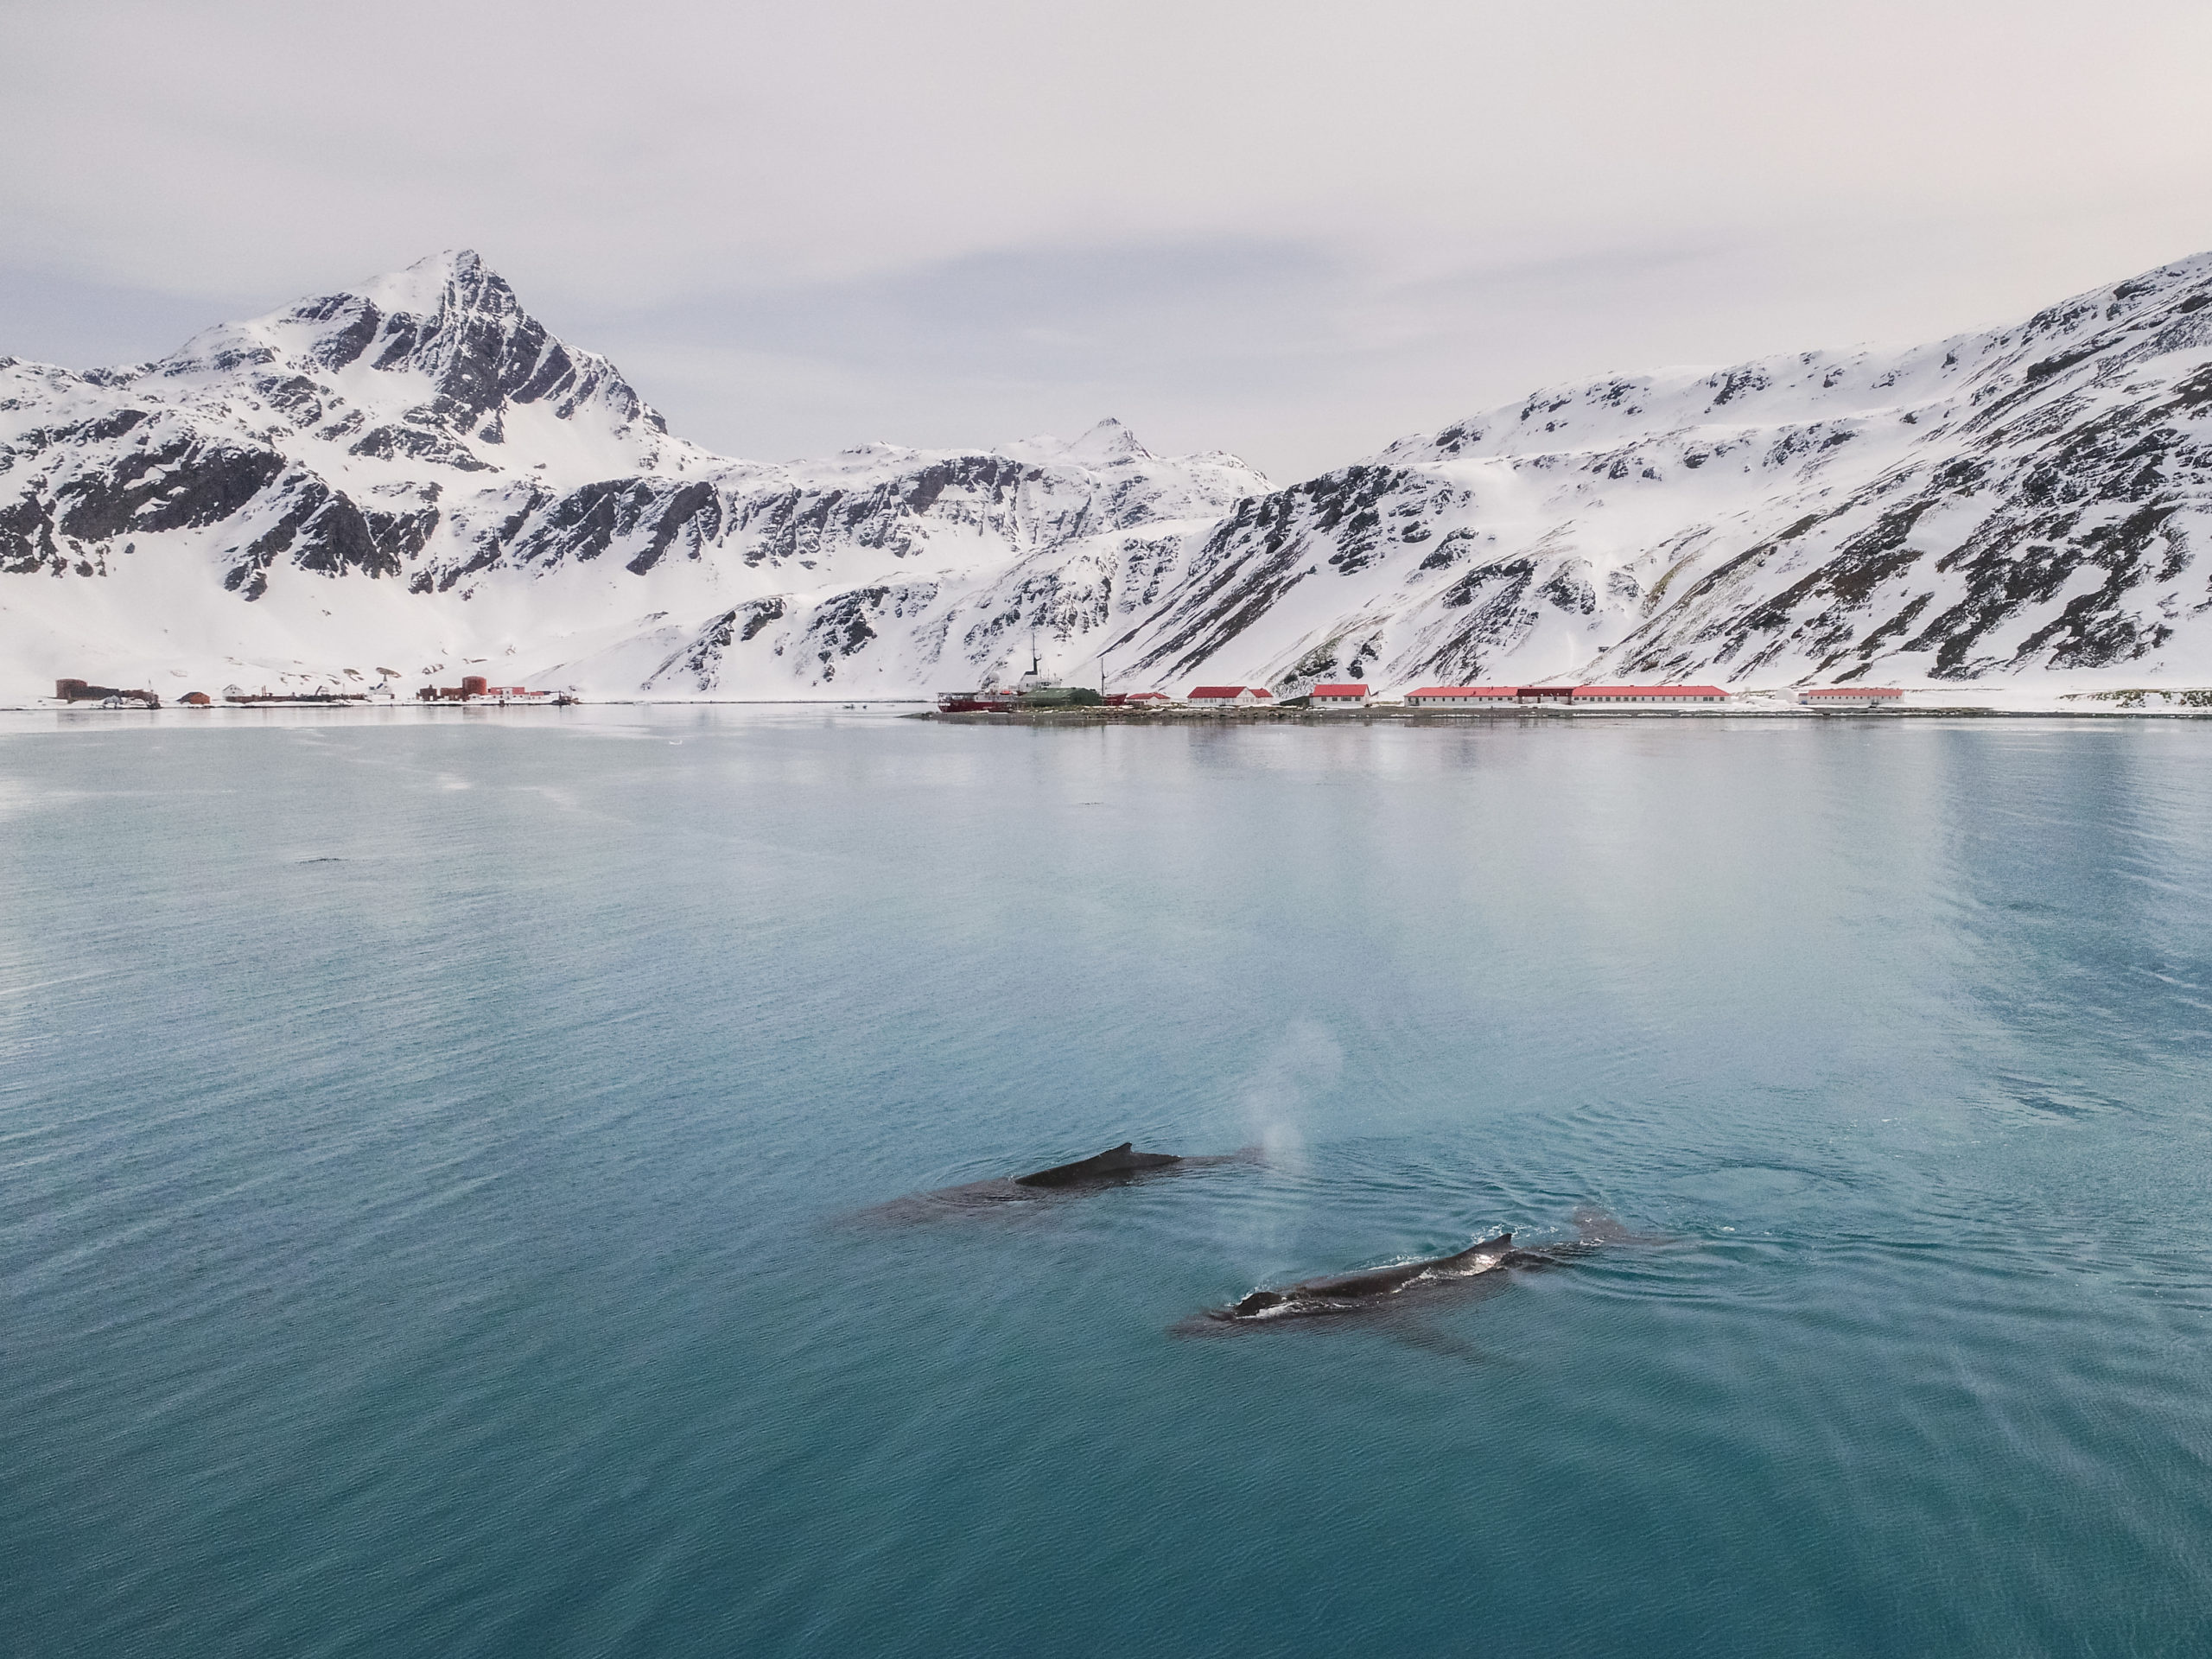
0;710;2212;1656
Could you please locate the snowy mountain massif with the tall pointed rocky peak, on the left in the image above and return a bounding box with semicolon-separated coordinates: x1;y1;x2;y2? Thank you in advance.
0;252;1268;699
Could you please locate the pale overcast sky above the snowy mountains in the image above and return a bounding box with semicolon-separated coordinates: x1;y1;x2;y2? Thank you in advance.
0;0;2212;480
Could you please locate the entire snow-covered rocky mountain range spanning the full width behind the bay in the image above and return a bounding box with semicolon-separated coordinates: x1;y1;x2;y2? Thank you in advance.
0;252;2212;702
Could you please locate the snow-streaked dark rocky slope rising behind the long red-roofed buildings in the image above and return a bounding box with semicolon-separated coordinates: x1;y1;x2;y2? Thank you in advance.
1106;254;2212;686
